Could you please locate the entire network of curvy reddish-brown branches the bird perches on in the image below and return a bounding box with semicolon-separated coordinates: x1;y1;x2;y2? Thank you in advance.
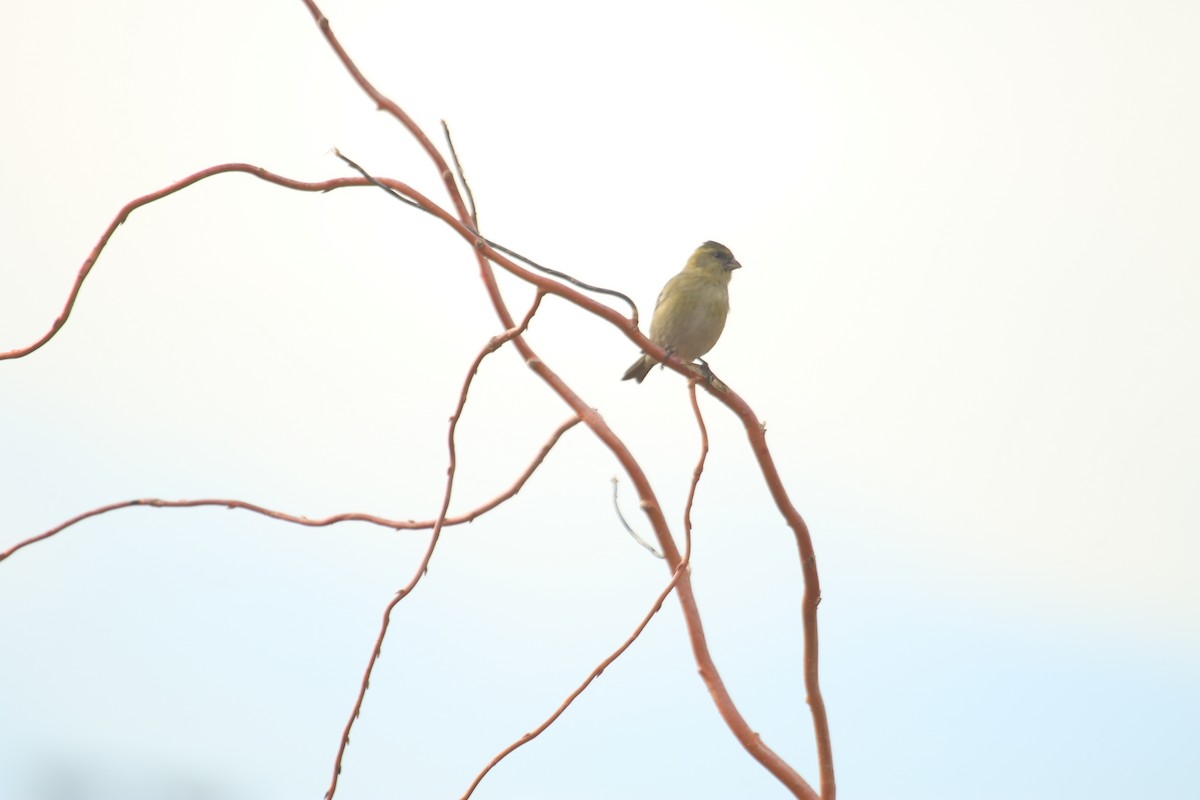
0;0;836;800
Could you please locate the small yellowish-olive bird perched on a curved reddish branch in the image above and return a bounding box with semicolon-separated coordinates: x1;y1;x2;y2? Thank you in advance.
622;241;742;383
